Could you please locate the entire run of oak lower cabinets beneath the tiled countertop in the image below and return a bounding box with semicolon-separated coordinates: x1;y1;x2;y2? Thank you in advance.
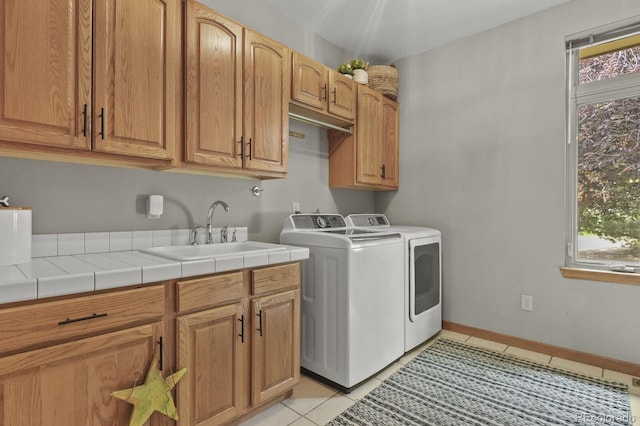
0;262;300;426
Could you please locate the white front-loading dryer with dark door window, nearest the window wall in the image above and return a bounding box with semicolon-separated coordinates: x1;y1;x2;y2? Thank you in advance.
346;214;442;351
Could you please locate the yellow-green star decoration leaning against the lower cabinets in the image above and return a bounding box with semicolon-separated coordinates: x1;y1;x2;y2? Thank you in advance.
111;356;187;426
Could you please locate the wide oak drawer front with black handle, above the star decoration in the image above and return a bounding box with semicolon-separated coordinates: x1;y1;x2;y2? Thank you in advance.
0;286;164;353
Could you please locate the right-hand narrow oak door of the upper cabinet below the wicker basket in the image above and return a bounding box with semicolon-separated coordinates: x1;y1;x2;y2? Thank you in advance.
382;98;400;188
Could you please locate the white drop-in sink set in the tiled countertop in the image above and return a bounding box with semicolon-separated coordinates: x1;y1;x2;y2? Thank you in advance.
140;241;286;260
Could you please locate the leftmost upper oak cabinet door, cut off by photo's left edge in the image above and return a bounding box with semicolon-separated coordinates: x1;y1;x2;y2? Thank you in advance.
0;0;92;150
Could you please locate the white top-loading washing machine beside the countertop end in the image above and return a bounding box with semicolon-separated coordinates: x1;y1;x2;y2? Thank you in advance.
280;214;405;392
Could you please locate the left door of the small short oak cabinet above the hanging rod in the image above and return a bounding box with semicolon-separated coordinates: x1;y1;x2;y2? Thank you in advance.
291;52;329;111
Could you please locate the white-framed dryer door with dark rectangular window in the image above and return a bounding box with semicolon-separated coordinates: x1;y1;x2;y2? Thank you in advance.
409;237;442;322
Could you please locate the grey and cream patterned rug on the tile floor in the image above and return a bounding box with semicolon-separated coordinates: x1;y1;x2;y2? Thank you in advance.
329;339;633;426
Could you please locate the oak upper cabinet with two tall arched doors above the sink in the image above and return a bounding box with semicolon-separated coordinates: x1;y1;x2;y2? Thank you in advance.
184;0;290;178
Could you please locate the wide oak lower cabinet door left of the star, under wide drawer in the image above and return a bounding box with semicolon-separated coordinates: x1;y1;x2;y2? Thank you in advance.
0;322;164;426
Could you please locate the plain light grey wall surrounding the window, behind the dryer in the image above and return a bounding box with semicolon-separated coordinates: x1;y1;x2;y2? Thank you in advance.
376;0;640;363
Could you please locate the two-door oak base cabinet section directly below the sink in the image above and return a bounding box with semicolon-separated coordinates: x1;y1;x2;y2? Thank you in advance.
177;263;300;426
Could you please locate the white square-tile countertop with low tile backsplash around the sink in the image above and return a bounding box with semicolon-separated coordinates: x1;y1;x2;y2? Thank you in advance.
0;228;309;303
